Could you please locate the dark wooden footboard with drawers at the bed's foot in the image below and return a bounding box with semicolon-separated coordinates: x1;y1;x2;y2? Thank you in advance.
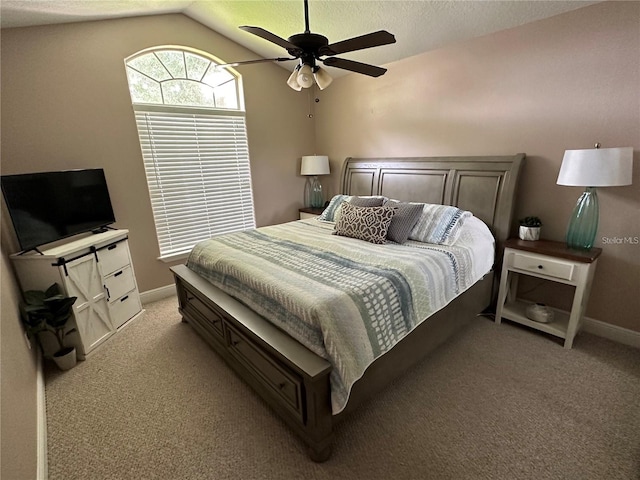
171;265;333;462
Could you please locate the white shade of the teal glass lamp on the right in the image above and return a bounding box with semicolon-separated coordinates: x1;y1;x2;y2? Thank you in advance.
557;147;633;187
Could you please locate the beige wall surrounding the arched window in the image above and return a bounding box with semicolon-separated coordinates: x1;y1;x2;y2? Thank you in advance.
1;14;314;292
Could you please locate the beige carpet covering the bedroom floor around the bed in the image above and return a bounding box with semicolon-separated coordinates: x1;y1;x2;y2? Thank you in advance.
46;297;640;480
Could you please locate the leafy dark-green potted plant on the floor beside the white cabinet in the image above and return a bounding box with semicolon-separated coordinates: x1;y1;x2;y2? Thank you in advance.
21;283;77;370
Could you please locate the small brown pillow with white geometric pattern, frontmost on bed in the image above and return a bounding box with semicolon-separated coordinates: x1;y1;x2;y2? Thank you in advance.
333;202;395;244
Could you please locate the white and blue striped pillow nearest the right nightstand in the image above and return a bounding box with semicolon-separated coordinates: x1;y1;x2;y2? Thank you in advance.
409;203;471;245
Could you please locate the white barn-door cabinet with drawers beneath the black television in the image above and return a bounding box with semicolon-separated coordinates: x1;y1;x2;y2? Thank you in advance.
11;229;144;358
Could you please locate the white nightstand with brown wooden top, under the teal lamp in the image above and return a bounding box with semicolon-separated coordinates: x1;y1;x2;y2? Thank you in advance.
496;238;602;348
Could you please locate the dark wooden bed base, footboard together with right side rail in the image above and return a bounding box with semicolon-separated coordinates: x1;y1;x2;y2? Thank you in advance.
171;265;493;462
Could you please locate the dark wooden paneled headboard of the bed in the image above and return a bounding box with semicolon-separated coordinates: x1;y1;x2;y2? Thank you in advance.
341;153;525;250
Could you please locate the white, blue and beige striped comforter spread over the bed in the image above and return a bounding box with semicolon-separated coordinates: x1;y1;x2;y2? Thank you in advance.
187;219;493;414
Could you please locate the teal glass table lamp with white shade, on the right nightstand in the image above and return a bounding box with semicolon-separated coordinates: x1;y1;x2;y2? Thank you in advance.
557;143;633;250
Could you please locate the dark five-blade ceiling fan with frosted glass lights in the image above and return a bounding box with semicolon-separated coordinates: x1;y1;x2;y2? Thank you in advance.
218;0;396;91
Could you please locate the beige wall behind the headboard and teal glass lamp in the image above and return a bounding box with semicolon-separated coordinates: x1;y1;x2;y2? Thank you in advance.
316;2;640;331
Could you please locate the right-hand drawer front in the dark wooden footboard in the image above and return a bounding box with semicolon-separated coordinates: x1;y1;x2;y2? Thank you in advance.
225;323;303;420
